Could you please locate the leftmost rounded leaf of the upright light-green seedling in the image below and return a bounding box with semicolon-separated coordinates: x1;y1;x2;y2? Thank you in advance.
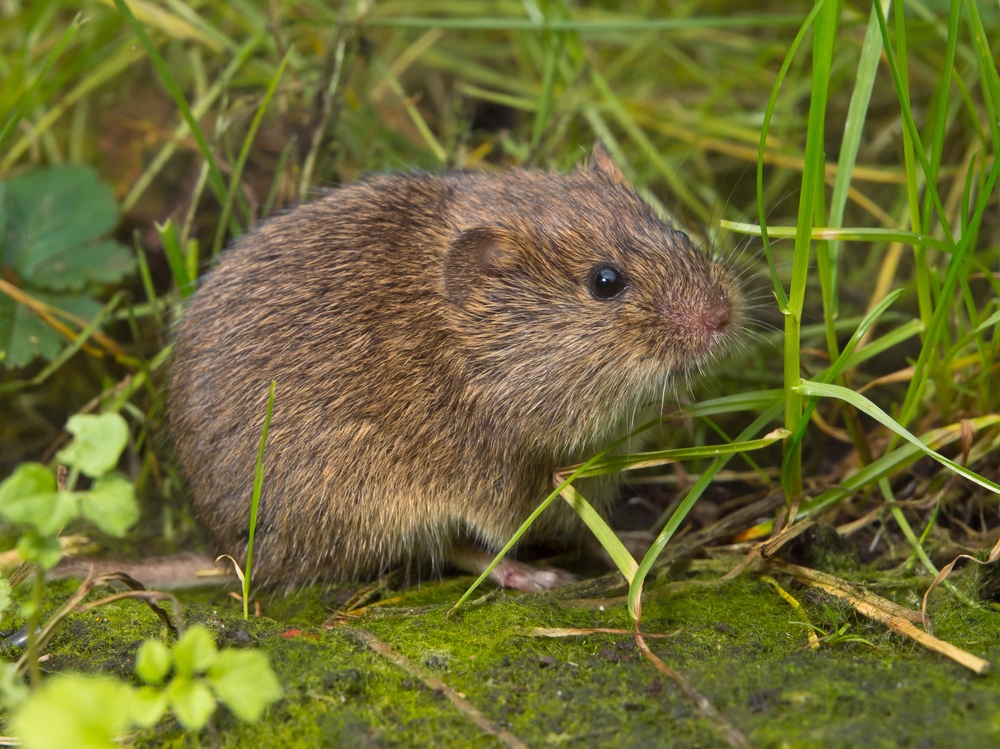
0;463;79;536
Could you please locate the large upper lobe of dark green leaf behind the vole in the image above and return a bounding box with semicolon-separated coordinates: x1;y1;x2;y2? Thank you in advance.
4;165;118;278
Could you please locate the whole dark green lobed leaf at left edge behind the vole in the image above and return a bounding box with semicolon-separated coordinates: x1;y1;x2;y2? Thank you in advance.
0;165;135;368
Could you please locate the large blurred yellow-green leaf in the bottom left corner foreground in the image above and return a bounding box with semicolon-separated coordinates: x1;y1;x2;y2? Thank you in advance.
10;674;131;749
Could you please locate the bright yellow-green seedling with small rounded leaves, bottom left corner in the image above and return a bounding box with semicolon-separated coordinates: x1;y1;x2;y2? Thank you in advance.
0;414;281;749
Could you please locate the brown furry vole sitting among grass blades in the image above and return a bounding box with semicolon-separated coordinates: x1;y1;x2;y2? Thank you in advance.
169;143;741;589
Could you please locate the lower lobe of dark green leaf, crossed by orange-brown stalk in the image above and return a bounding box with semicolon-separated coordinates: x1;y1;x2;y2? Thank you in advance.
0;291;101;369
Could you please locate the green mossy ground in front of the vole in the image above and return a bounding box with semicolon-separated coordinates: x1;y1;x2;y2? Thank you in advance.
21;552;1000;749
